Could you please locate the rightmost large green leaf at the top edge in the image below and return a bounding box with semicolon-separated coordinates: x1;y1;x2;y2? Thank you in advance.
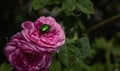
77;0;94;14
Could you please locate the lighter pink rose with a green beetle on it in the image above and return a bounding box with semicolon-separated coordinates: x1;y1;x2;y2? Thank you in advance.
21;16;65;52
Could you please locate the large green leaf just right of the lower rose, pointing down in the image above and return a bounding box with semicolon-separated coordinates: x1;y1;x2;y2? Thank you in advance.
58;44;78;68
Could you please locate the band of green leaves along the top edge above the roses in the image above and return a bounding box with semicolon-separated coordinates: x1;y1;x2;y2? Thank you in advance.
32;0;94;15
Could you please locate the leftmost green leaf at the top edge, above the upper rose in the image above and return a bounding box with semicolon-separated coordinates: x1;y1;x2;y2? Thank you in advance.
32;0;49;10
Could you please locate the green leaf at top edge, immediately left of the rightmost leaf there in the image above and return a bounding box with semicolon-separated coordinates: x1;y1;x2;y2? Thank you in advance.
62;0;76;12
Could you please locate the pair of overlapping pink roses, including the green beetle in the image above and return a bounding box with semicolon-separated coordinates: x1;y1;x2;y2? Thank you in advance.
4;16;65;71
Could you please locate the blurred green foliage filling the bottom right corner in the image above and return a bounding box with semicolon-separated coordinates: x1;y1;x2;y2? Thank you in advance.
86;35;120;71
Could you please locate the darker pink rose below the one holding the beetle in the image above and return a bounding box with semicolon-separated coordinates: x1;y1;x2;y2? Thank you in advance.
4;33;51;71
